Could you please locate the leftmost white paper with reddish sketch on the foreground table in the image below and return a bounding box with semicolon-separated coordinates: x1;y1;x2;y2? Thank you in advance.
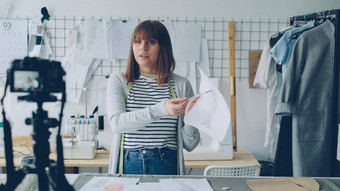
80;177;139;191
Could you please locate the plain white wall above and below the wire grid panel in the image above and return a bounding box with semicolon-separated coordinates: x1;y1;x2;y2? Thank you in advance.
0;0;340;162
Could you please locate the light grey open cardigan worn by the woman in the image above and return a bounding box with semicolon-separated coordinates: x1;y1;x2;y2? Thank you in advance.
107;72;200;175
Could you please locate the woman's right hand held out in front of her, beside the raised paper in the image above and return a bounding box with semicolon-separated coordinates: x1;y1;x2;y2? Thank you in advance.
164;98;188;117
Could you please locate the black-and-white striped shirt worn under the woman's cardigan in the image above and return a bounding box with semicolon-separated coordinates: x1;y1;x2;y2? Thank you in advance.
124;76;177;150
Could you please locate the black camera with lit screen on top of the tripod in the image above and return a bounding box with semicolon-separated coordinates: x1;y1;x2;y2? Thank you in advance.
8;57;65;93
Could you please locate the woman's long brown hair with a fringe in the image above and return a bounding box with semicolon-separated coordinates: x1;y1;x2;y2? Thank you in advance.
125;20;175;85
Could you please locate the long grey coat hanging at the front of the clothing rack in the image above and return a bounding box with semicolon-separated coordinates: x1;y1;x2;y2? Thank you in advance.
275;20;337;177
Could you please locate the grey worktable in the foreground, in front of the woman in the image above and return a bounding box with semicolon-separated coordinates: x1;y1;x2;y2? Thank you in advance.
73;174;340;191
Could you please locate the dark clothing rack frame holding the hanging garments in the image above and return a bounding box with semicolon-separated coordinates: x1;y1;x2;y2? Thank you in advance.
290;9;340;176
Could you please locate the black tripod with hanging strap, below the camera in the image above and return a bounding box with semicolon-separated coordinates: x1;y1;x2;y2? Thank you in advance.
0;92;74;191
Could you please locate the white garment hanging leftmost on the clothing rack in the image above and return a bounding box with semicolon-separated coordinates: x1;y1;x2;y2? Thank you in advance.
253;40;278;160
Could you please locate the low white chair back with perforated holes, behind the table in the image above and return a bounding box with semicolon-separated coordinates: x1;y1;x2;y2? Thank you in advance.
204;164;261;176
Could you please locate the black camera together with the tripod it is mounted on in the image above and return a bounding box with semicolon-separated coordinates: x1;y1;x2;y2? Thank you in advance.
0;57;74;190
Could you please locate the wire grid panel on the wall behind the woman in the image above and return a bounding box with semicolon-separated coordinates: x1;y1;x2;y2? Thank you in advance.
41;17;289;80
